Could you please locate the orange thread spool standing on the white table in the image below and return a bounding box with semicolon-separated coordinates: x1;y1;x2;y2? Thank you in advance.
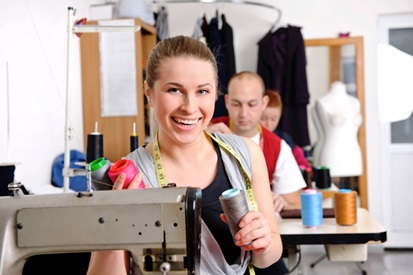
334;189;357;225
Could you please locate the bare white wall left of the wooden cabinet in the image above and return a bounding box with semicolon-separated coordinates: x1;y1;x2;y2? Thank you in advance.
0;0;103;194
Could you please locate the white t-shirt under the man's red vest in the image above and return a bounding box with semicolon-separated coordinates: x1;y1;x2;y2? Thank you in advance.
251;133;307;195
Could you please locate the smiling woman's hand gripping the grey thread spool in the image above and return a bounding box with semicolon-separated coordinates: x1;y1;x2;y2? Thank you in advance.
221;210;272;254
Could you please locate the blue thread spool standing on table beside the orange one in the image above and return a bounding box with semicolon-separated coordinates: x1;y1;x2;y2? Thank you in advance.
300;189;323;227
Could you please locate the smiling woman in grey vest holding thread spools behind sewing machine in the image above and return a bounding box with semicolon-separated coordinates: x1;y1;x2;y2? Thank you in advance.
88;36;282;275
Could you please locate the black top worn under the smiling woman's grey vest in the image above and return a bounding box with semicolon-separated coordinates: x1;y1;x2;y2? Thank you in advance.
201;141;241;264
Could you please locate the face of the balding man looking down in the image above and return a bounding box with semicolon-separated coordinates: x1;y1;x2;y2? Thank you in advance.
225;76;268;137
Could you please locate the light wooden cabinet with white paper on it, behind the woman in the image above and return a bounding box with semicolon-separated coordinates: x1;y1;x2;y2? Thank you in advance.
80;19;156;162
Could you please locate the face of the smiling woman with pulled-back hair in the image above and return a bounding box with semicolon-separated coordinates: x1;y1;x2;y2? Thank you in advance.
145;57;217;146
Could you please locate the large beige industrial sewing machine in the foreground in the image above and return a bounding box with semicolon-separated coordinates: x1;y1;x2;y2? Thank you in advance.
0;187;201;275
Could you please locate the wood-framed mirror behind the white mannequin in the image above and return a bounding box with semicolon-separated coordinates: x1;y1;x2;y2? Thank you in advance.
305;37;368;209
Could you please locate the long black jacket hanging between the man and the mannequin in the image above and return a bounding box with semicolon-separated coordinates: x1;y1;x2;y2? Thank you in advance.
257;25;310;147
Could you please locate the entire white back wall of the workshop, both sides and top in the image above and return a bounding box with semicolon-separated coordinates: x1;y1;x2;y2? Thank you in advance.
0;0;413;224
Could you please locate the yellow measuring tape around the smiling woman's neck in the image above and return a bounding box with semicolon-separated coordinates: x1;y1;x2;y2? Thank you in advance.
152;131;258;275
